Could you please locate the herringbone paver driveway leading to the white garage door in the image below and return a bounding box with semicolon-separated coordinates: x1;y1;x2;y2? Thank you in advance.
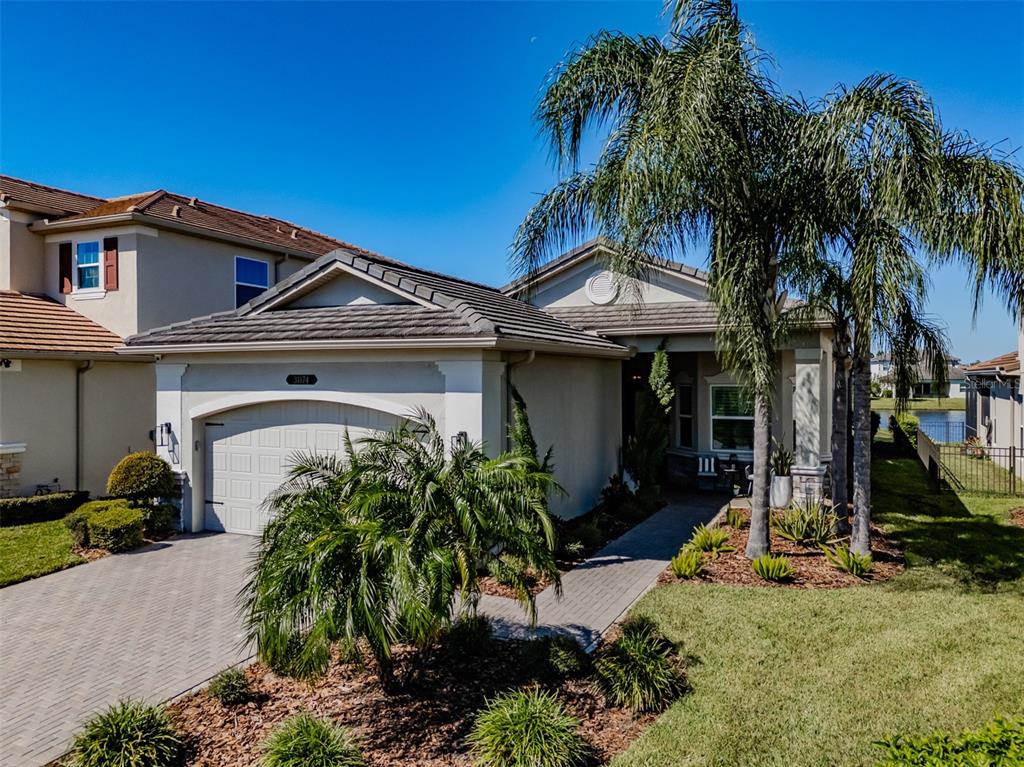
0;535;256;767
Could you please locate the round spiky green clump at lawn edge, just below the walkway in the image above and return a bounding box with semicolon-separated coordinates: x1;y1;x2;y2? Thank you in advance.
595;620;686;712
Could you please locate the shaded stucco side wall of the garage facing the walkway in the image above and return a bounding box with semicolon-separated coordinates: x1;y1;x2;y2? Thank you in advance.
510;354;622;519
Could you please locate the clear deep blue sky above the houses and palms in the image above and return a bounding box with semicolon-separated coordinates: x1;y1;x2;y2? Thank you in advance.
0;2;1024;359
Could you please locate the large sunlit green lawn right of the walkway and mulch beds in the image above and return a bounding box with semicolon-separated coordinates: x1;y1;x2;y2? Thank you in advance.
613;430;1024;767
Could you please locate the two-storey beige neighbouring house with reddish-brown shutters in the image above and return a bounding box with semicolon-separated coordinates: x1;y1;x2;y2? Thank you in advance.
0;176;368;496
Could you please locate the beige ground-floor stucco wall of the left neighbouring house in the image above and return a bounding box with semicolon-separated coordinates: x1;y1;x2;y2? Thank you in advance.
0;359;156;495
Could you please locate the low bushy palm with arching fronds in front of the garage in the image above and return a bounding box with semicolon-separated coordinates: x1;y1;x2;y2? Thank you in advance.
242;412;559;684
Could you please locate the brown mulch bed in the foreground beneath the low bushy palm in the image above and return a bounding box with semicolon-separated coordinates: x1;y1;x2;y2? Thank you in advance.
169;642;653;767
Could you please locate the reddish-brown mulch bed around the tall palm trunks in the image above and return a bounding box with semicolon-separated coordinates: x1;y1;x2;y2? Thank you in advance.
658;509;905;589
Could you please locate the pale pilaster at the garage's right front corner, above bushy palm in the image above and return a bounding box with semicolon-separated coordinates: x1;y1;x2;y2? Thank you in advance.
437;359;505;456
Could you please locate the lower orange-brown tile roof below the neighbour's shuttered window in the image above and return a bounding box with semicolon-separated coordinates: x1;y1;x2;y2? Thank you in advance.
0;291;121;355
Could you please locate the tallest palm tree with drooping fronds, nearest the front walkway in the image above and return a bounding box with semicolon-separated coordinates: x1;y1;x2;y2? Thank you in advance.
512;0;813;557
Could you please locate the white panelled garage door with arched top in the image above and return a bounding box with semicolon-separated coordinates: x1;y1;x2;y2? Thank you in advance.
205;401;399;535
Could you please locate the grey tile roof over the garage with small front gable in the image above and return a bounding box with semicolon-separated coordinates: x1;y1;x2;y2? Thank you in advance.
126;249;628;355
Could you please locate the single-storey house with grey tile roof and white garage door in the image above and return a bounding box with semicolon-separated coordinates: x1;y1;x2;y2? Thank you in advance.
122;241;831;534
